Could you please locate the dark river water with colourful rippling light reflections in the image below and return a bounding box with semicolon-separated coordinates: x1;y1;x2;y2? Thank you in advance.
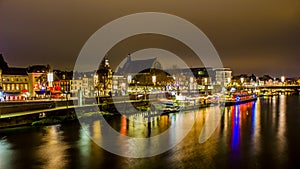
0;95;300;169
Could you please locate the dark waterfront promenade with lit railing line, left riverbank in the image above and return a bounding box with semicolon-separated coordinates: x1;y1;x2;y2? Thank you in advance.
0;97;155;128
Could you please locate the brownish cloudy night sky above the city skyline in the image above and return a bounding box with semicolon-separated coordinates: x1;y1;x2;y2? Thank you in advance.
0;0;300;77
